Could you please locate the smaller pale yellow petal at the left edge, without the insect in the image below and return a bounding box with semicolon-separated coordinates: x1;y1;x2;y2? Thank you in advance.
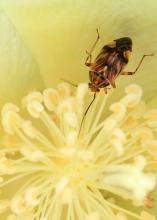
0;11;43;104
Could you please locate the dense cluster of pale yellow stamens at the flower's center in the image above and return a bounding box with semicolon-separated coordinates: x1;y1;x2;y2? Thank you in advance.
0;83;157;220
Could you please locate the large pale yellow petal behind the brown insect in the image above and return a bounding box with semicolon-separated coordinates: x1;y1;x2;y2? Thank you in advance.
1;0;157;99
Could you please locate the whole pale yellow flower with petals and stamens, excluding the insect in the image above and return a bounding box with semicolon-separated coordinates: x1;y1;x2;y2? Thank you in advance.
0;0;157;220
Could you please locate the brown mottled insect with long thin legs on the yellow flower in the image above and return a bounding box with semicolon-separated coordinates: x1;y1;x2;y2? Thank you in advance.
79;29;153;133
